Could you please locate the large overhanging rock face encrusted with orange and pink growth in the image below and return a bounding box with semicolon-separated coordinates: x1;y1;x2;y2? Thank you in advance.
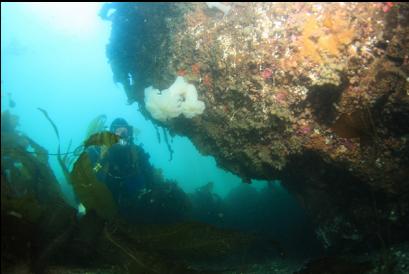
102;3;409;250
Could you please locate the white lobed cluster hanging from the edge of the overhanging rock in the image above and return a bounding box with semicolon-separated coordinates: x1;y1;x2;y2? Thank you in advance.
145;76;205;122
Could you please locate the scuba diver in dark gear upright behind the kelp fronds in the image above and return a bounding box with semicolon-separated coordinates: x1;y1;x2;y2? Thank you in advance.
88;118;149;211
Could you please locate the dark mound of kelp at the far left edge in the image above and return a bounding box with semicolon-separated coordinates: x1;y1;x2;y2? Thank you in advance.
1;111;75;271
